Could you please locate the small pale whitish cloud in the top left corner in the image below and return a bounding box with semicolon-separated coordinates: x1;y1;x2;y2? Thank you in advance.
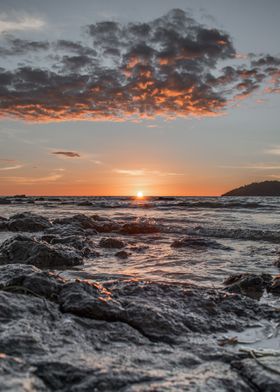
0;13;45;33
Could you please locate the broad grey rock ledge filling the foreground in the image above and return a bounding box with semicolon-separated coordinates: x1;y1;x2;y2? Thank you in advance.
0;264;280;392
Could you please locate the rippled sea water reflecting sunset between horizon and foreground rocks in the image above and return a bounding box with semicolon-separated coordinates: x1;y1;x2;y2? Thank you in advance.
0;197;280;287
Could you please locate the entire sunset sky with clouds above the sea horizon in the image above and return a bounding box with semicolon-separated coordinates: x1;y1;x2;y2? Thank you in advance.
0;0;280;196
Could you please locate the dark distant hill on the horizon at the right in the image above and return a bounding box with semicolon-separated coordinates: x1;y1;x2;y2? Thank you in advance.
222;181;280;196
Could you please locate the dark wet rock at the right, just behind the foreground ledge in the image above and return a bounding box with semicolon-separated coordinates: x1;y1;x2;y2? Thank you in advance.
223;273;272;299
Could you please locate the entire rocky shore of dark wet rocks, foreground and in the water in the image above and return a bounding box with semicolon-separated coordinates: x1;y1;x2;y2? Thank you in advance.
0;213;280;392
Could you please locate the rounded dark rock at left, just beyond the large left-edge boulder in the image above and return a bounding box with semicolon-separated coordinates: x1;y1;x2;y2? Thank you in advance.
8;212;51;232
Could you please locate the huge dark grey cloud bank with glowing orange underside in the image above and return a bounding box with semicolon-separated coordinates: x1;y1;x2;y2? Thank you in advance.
0;9;280;121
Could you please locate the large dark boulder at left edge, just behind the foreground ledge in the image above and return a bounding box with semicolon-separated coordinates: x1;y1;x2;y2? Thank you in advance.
0;235;83;268
